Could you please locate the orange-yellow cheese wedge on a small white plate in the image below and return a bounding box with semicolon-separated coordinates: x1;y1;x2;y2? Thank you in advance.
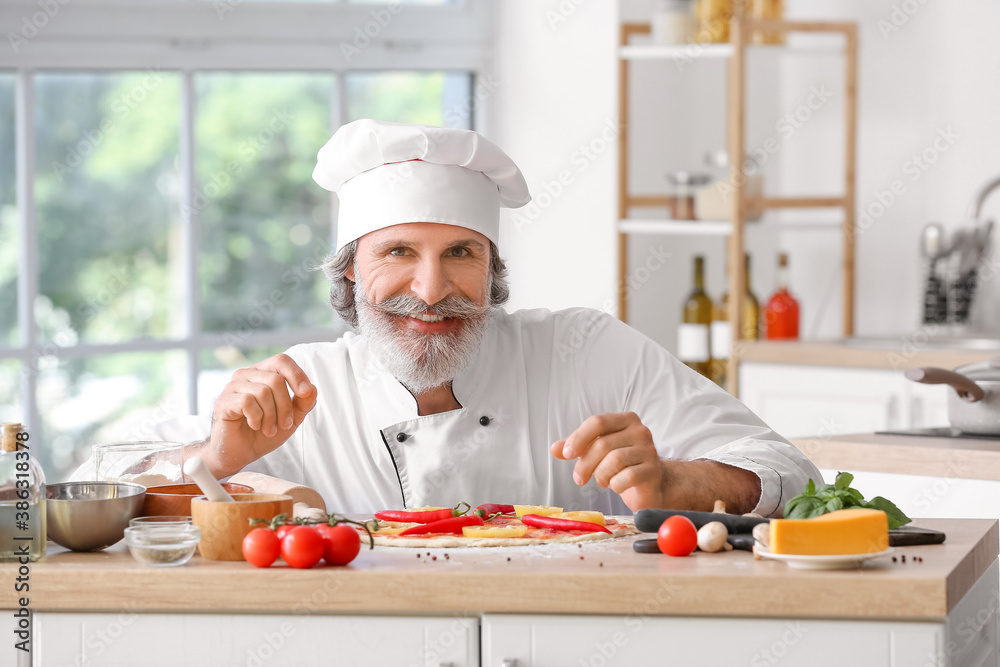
768;508;889;556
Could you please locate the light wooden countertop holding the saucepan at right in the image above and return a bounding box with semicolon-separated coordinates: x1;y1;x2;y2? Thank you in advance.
791;433;1000;481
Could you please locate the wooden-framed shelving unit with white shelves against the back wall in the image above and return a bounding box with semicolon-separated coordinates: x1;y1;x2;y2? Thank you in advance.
615;12;858;395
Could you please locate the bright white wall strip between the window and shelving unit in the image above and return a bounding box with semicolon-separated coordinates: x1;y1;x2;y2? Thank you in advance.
488;0;618;309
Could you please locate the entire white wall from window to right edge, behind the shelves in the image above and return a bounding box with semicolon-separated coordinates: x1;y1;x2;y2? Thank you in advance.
489;0;1000;348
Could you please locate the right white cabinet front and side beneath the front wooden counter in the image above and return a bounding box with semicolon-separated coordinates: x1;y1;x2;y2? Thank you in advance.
482;561;998;667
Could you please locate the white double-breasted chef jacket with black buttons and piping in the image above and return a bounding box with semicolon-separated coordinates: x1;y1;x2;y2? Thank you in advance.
148;308;822;516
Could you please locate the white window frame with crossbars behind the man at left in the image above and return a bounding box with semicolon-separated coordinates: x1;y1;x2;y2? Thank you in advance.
0;0;494;448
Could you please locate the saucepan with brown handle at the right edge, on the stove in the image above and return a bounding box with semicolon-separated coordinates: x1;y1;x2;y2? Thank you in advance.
905;357;1000;435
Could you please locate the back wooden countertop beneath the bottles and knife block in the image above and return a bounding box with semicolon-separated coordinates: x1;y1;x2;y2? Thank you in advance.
739;337;1000;371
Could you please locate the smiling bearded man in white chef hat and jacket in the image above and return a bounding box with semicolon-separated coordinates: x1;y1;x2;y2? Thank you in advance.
160;120;820;515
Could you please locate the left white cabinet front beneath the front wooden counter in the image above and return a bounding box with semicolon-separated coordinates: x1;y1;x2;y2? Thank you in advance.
33;609;479;667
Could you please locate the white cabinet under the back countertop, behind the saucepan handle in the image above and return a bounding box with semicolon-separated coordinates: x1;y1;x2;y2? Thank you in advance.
739;362;948;438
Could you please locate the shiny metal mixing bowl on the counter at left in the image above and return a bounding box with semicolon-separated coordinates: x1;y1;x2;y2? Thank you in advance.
45;482;146;551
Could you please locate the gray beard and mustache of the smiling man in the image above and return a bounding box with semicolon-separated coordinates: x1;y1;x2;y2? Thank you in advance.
354;282;493;396
